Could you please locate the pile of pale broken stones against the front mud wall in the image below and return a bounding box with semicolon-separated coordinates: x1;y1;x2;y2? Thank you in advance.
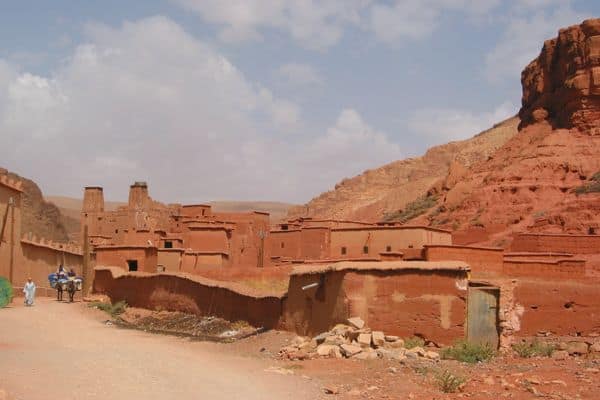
279;317;440;361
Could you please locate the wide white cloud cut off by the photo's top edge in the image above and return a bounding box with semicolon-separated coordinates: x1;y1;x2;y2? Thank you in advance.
172;0;500;50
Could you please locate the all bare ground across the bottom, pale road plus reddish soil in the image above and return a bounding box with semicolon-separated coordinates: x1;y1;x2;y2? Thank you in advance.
0;299;600;400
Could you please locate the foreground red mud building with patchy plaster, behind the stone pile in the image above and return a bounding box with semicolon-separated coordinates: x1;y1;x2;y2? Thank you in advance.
282;261;468;344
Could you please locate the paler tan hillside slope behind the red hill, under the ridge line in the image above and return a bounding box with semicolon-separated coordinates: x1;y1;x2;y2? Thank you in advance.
289;117;519;221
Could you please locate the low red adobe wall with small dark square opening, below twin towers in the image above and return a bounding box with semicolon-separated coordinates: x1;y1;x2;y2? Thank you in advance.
94;246;158;272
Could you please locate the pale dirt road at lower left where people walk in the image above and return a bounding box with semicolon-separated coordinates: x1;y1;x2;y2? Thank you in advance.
0;299;321;400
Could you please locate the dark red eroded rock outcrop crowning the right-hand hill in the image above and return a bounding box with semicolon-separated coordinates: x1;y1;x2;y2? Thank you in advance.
519;19;600;135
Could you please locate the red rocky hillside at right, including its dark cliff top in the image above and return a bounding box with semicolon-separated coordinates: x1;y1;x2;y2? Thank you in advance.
413;19;600;244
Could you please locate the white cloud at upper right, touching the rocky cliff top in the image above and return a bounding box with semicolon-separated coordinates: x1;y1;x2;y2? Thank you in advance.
484;0;587;83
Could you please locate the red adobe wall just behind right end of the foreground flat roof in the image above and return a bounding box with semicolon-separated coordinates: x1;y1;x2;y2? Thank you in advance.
425;245;504;276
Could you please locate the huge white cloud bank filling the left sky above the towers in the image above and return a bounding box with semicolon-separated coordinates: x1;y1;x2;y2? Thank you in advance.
0;17;400;202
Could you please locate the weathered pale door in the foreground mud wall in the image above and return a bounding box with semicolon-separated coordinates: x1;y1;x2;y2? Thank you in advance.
467;283;500;349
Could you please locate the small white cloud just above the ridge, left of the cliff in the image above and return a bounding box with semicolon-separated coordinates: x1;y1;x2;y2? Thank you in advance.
409;102;518;144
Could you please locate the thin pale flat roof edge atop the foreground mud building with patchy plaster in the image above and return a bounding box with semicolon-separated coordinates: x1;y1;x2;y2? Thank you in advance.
291;261;471;275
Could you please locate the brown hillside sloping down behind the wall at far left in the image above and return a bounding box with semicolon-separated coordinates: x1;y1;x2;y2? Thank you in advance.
0;168;69;242
